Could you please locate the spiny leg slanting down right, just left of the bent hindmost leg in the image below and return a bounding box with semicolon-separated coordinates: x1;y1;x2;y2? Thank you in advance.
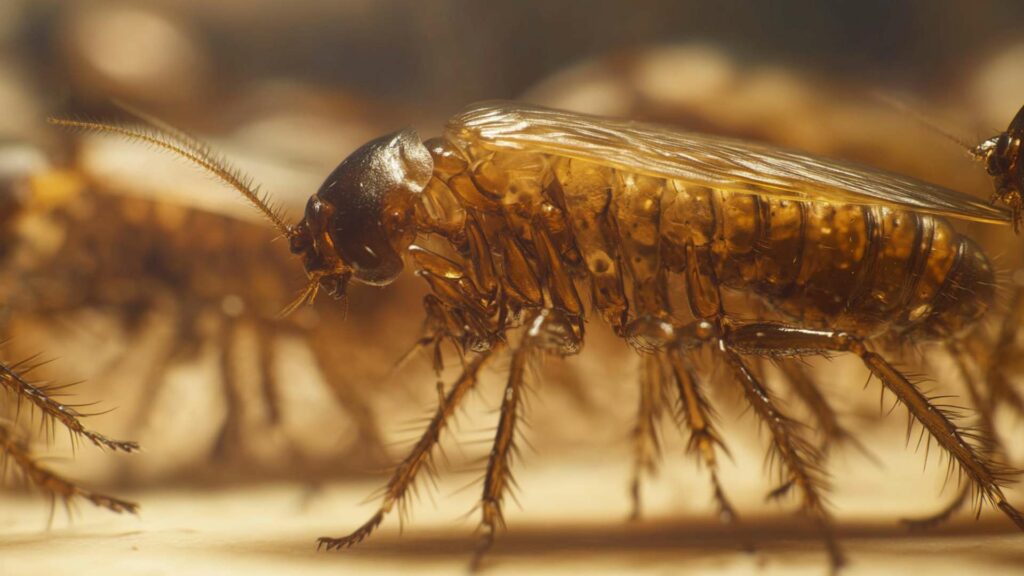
719;342;846;571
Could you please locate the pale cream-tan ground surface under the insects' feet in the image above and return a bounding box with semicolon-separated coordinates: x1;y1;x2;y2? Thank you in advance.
0;416;1024;576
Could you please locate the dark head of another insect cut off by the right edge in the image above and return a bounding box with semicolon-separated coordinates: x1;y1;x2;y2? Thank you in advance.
974;107;1024;231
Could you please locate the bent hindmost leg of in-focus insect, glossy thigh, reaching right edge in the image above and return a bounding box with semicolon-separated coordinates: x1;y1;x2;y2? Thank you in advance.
725;323;1024;530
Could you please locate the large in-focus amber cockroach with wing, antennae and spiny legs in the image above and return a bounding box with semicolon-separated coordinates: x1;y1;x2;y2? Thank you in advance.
54;101;1024;567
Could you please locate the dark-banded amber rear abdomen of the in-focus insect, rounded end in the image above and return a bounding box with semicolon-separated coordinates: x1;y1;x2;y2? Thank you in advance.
660;177;994;336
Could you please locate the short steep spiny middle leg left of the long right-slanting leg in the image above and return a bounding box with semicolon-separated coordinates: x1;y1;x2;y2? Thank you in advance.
669;349;738;522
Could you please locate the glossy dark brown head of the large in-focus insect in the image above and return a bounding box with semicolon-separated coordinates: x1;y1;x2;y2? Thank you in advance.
289;130;433;297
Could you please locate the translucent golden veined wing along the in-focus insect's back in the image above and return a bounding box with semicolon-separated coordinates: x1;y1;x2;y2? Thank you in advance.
446;101;1011;223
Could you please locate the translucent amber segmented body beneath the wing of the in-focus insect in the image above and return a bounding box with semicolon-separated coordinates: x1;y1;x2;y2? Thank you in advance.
417;141;993;336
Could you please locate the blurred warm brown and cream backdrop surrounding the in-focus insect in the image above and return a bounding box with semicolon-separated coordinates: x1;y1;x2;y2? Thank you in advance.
0;0;1024;575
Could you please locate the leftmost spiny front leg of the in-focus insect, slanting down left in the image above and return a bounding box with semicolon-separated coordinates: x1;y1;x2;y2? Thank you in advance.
316;342;502;550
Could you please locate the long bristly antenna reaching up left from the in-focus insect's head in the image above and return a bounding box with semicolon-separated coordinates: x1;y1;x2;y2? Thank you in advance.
47;114;294;238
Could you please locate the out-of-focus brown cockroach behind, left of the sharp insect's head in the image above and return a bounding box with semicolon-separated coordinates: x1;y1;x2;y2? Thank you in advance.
5;142;415;476
